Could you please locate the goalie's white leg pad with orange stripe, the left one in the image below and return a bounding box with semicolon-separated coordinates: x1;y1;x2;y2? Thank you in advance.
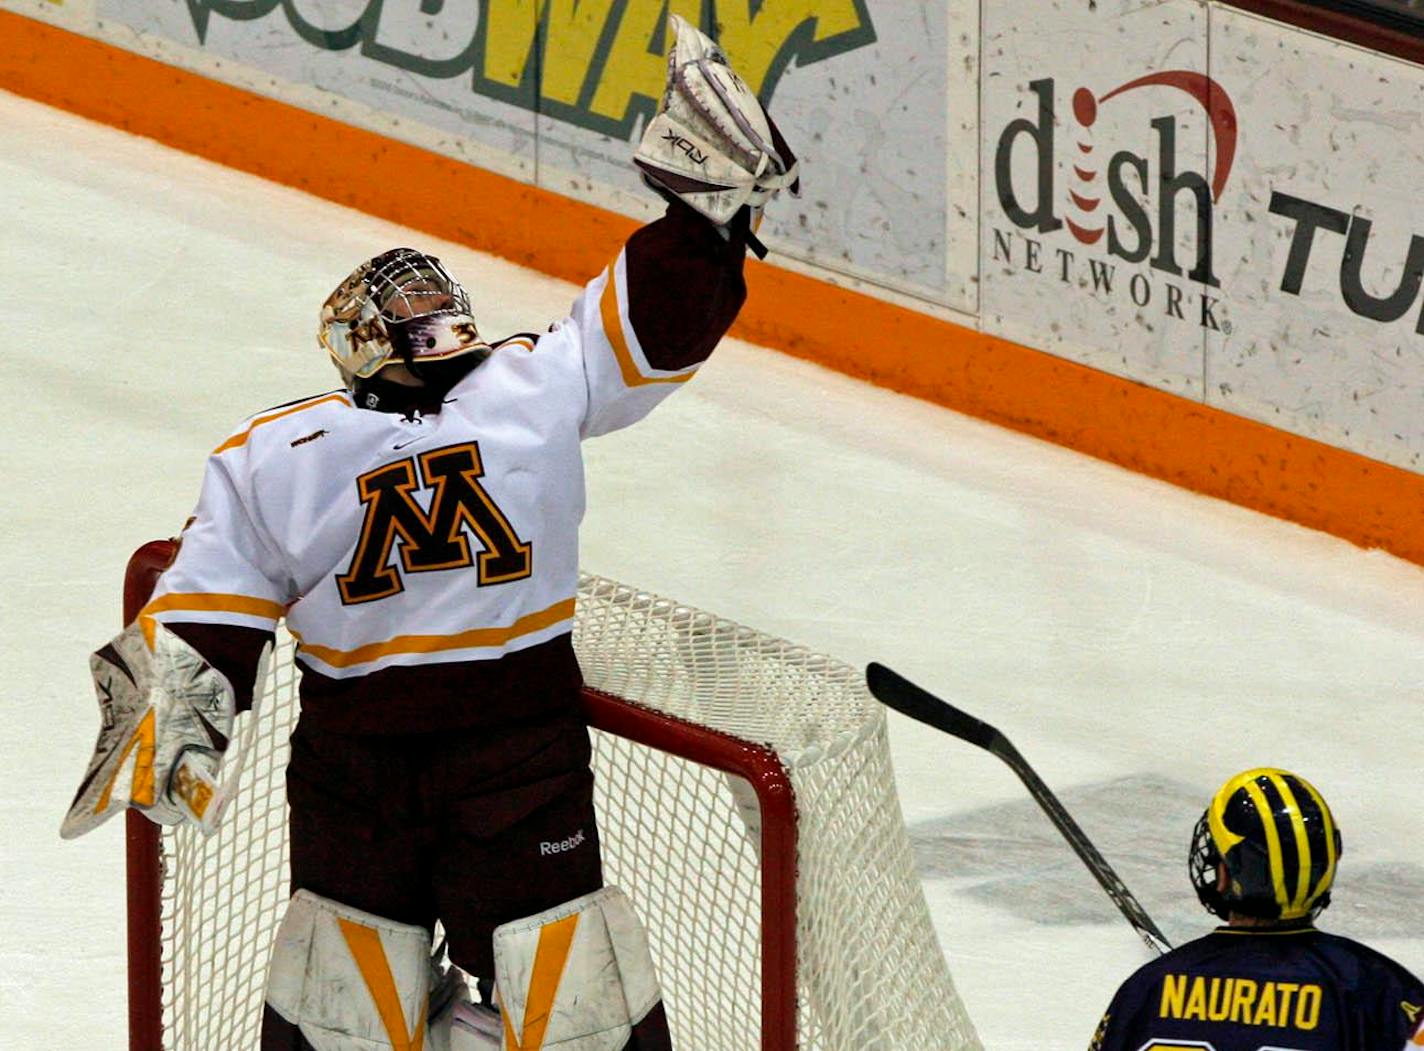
266;890;430;1051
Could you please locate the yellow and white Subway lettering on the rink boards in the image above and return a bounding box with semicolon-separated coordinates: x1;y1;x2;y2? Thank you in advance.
185;0;876;140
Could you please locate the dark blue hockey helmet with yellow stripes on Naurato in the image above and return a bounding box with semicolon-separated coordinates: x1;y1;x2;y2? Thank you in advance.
1188;768;1340;921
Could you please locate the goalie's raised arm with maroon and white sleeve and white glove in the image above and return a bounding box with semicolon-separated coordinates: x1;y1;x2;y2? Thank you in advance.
563;16;799;437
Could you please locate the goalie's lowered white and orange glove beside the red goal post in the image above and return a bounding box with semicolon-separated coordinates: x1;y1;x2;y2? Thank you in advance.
60;618;271;839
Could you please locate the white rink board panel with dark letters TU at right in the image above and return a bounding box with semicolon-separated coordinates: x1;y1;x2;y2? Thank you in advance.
1206;7;1424;470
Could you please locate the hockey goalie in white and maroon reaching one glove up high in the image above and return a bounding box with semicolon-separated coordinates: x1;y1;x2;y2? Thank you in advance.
61;17;797;1051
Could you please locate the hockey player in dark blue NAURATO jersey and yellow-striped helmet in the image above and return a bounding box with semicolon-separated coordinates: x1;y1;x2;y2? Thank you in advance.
1091;769;1424;1051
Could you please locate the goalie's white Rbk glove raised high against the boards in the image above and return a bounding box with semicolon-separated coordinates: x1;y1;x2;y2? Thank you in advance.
634;14;800;256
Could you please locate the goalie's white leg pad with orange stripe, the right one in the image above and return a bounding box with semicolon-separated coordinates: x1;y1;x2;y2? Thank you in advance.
494;887;662;1051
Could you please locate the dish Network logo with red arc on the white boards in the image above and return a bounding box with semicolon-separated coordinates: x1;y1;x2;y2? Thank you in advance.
994;70;1236;330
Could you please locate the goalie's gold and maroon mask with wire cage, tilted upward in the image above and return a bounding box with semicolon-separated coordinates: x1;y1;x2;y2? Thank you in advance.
319;248;490;387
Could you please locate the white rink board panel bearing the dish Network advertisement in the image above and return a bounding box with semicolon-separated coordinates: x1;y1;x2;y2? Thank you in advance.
980;0;1230;397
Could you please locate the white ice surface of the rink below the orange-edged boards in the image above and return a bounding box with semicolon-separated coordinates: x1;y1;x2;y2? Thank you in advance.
0;94;1424;1051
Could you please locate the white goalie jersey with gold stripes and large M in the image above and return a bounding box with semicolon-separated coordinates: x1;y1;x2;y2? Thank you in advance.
142;223;742;725
